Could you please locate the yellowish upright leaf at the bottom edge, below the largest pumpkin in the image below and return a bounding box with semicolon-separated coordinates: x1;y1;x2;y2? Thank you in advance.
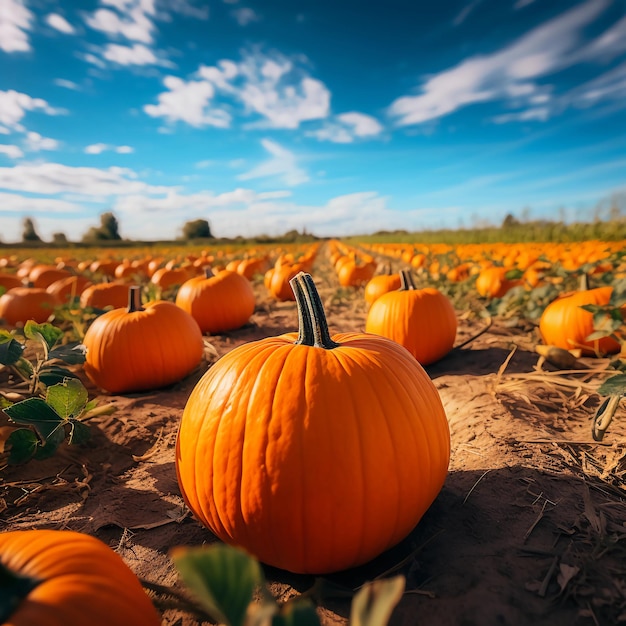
350;576;405;626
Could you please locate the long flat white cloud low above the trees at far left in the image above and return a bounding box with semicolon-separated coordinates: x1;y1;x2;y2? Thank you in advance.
0;163;171;196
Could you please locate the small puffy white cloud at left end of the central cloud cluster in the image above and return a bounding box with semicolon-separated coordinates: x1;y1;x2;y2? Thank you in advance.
143;76;231;128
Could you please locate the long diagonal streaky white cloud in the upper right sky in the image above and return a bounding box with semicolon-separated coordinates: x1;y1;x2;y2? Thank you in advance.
388;0;609;126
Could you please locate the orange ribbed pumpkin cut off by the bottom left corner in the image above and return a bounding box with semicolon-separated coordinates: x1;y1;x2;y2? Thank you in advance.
0;530;161;626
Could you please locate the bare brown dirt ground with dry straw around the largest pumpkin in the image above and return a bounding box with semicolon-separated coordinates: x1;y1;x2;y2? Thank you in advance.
0;254;626;626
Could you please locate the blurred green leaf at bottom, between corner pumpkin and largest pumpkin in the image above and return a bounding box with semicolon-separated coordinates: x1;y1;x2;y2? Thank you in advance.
172;545;264;626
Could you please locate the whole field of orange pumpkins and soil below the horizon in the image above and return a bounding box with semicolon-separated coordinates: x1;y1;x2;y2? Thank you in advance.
0;239;626;626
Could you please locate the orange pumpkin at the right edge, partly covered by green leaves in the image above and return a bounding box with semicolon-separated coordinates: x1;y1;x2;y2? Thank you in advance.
539;287;620;354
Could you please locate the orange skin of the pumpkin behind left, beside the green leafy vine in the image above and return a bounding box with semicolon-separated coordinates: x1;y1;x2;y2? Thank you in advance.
83;300;204;393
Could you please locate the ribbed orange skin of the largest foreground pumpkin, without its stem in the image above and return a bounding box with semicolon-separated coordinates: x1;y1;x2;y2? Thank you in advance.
176;333;450;574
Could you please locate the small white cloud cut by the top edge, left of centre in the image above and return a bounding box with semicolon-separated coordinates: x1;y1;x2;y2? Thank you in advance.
85;0;156;44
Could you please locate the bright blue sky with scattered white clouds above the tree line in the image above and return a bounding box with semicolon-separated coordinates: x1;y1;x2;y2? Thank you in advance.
0;0;626;242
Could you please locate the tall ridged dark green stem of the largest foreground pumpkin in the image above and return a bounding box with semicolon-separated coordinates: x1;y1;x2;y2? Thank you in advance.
289;272;339;350
